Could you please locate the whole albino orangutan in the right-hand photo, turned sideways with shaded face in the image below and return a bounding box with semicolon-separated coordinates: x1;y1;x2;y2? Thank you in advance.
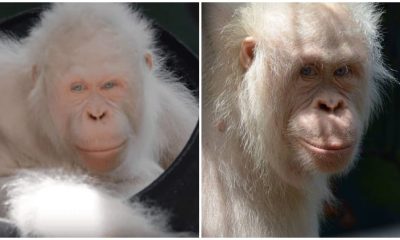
202;3;392;237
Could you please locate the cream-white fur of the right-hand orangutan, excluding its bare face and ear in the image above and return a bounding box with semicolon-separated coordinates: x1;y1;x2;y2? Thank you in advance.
202;3;392;237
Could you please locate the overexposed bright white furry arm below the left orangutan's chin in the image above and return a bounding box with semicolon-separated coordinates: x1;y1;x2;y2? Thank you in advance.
3;172;169;237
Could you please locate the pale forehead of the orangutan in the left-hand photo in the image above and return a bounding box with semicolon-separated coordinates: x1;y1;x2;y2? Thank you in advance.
46;31;139;79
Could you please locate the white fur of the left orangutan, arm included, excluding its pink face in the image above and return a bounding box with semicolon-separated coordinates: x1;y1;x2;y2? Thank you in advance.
0;4;198;237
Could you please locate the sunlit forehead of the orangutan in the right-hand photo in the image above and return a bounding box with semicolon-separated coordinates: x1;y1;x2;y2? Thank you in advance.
263;3;368;61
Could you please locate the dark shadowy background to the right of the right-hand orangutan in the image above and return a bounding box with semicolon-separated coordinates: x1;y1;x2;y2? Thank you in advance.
321;3;400;237
